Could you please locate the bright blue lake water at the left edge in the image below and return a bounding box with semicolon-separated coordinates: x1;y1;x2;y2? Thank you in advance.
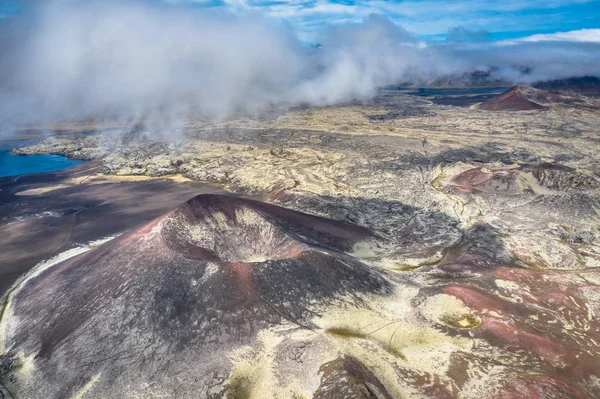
0;142;86;177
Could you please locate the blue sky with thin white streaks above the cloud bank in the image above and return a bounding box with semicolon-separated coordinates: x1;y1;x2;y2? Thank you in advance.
0;0;600;40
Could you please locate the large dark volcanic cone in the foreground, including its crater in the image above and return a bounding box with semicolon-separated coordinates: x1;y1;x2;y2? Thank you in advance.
0;195;391;398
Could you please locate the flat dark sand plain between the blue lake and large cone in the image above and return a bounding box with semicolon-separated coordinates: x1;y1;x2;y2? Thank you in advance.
0;161;223;296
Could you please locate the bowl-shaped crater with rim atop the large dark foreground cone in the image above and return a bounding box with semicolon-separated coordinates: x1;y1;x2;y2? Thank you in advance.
162;195;370;262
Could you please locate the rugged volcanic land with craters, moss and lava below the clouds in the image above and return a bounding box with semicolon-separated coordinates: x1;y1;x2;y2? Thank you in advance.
0;87;600;399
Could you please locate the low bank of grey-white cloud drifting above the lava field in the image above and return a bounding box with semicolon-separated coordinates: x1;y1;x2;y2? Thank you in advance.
0;0;600;136
